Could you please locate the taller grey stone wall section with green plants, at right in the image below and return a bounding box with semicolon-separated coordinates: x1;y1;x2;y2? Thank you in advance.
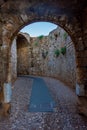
48;27;76;87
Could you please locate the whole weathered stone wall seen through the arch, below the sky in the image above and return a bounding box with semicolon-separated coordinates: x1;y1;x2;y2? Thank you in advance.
17;27;76;87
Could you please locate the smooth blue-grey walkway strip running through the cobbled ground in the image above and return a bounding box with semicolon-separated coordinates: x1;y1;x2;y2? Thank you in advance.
29;77;56;112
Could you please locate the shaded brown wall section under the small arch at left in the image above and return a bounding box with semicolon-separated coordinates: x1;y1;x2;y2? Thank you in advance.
17;34;31;75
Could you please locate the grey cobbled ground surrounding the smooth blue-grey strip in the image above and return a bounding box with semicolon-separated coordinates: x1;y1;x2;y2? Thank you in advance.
0;77;87;130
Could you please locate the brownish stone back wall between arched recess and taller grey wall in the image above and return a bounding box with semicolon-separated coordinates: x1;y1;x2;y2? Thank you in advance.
29;37;48;76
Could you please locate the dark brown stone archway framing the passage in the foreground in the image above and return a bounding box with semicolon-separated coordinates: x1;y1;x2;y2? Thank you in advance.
0;0;87;116
